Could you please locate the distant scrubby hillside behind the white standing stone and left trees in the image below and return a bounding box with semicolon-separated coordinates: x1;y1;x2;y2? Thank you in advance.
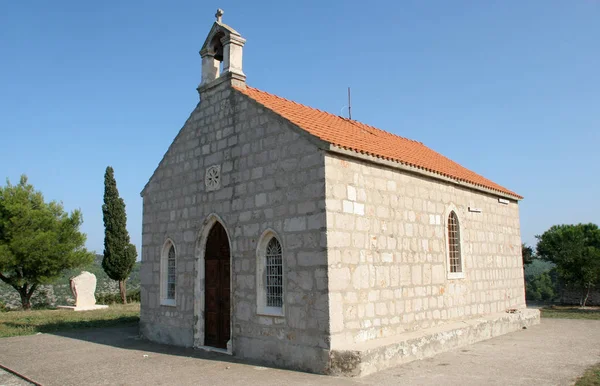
0;255;140;308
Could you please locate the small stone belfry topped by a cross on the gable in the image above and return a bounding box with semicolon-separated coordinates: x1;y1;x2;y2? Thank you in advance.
198;9;246;92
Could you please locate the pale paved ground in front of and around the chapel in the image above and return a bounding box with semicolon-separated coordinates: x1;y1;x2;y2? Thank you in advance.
0;319;600;386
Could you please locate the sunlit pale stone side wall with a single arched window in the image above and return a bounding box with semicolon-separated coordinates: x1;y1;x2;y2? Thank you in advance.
325;153;525;349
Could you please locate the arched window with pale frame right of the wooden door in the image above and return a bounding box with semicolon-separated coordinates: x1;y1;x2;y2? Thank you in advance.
256;230;285;316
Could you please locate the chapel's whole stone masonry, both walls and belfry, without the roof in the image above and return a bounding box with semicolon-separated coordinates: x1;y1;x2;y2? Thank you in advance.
140;11;539;375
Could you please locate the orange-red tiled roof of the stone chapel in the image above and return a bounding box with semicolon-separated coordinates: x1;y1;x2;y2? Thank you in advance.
236;87;523;199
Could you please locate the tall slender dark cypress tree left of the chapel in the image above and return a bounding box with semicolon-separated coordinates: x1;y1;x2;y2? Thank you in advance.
102;166;137;304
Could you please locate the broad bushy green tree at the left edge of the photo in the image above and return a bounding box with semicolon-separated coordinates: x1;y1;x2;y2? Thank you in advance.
0;175;94;310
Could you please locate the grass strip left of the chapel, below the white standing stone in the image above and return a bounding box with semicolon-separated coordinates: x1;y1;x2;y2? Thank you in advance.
0;303;140;338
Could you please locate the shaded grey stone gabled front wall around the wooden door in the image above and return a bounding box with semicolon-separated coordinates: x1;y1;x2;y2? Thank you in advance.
140;82;329;371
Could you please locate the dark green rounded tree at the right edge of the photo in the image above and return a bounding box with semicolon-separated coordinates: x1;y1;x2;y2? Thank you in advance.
536;223;600;307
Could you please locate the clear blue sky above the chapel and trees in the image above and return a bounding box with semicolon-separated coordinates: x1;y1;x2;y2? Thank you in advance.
0;0;600;253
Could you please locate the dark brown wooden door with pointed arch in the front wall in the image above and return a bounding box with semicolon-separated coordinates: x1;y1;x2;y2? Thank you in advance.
204;222;231;348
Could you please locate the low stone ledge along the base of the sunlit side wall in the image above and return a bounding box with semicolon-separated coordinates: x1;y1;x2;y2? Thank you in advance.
327;309;540;377
